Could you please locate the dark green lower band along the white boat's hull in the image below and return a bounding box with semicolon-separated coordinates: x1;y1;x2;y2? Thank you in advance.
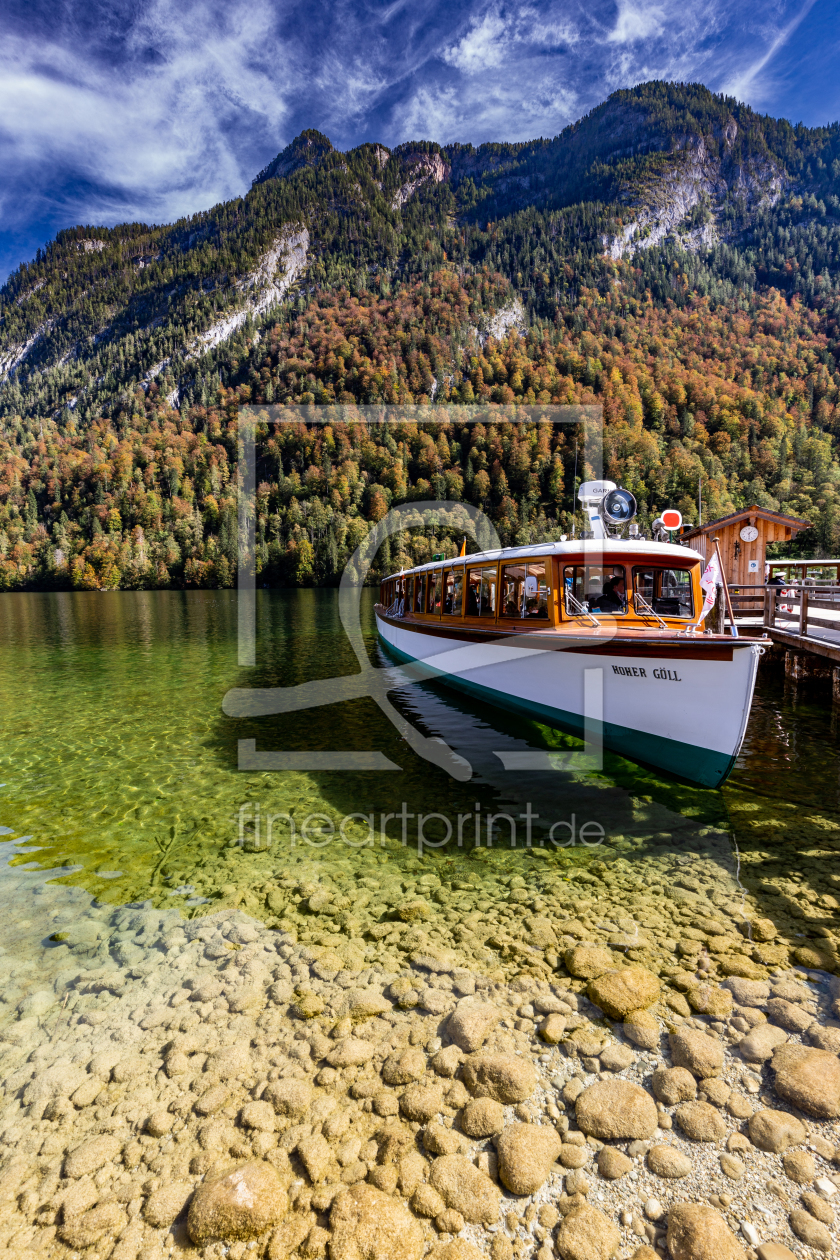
380;635;735;788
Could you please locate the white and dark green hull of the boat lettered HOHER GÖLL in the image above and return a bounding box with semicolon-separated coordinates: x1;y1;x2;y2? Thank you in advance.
377;611;761;788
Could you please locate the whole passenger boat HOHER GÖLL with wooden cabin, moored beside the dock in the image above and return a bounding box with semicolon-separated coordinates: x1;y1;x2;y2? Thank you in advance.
375;483;763;788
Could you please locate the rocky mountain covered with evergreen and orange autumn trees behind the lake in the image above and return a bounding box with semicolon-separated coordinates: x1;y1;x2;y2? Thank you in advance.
0;83;840;588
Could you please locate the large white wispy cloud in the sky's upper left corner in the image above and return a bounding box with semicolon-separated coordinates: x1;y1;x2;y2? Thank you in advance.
0;3;295;231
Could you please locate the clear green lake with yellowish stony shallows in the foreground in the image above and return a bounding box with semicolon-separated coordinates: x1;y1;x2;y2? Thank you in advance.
0;590;840;1260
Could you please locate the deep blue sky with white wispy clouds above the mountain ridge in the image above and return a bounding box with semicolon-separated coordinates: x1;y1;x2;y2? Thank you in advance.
0;0;840;281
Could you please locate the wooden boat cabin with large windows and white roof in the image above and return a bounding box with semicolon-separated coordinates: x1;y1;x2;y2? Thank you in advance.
379;539;703;631
